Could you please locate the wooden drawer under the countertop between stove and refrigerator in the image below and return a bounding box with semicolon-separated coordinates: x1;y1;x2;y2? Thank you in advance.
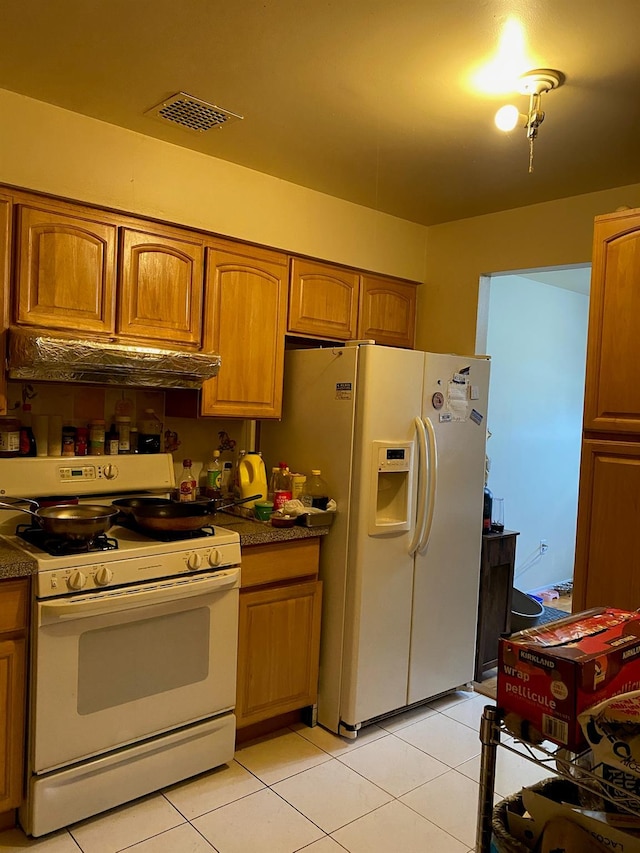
241;536;320;589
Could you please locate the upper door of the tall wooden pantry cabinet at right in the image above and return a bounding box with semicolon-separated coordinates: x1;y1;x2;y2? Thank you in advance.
584;210;640;433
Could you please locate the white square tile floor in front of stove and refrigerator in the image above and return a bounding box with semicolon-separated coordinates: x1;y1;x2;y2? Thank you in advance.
0;691;548;853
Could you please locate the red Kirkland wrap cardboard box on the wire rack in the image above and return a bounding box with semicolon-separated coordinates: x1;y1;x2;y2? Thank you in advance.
497;607;640;752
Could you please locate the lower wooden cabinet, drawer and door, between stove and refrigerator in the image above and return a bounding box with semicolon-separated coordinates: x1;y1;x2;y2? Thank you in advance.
236;538;322;728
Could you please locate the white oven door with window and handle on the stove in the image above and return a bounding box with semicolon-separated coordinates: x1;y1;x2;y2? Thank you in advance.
31;568;240;773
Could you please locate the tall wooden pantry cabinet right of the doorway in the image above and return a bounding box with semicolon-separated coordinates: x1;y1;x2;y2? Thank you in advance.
573;209;640;611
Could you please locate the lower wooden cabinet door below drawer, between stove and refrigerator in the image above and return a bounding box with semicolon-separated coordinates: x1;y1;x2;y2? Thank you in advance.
236;581;322;727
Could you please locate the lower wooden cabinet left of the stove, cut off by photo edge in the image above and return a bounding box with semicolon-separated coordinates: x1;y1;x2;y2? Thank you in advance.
0;579;29;826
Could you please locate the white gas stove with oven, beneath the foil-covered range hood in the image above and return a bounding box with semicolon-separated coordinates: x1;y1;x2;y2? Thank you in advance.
0;454;240;836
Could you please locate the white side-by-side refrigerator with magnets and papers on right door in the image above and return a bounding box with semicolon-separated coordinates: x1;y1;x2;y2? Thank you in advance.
260;343;489;737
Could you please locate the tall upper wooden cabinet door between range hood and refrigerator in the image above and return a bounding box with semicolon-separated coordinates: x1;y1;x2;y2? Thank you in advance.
202;243;287;418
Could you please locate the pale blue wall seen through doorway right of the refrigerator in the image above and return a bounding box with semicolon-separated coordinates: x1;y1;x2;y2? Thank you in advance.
476;264;591;594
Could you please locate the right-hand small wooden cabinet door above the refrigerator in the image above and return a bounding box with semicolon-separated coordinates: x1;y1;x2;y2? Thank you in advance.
358;275;417;349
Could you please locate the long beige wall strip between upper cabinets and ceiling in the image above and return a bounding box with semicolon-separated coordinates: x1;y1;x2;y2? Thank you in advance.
0;89;427;281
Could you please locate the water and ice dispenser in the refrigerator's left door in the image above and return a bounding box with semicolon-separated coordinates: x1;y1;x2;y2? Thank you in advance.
369;441;413;536
